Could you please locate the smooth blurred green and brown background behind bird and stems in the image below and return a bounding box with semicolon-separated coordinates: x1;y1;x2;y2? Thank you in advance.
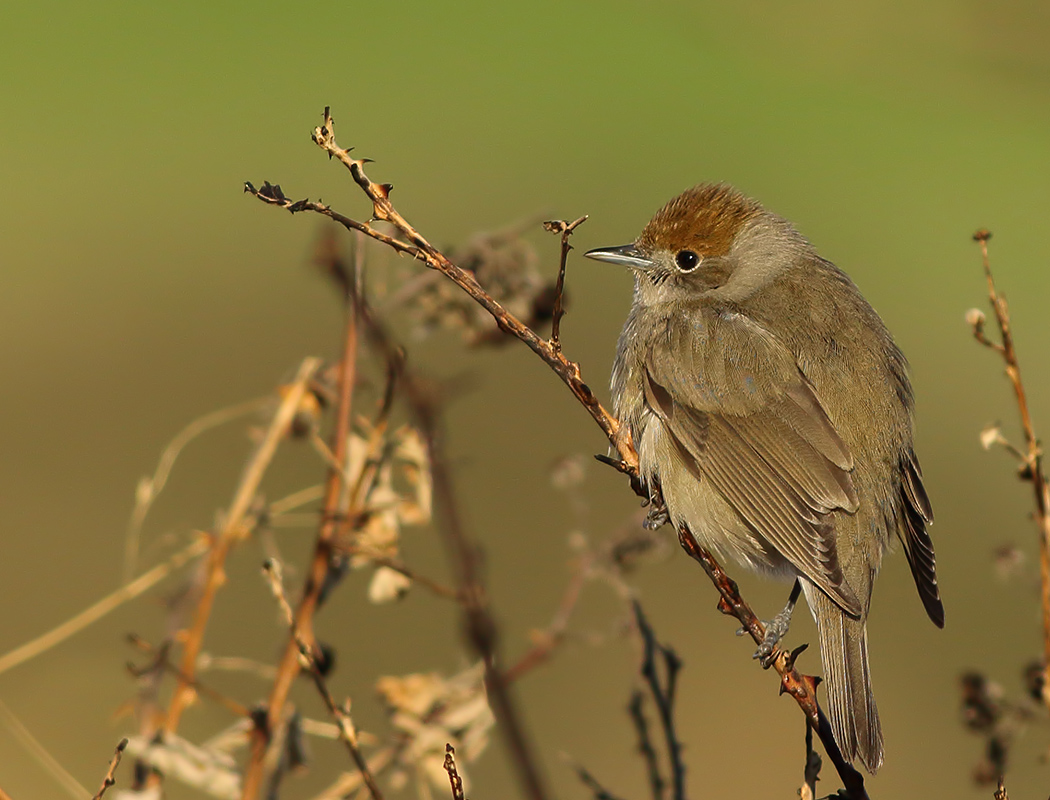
0;0;1050;800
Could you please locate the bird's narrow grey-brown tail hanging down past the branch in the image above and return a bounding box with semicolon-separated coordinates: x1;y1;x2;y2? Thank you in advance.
802;581;882;774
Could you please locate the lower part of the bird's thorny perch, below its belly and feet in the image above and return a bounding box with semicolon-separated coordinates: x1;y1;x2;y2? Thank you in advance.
678;527;867;800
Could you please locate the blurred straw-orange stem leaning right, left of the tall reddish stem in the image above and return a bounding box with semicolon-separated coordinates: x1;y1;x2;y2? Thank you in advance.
164;358;320;733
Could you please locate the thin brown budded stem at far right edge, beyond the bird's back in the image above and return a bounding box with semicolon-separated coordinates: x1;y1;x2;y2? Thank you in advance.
971;230;1050;709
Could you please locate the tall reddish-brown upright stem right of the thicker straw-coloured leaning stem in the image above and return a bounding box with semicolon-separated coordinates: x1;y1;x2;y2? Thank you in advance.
242;302;358;800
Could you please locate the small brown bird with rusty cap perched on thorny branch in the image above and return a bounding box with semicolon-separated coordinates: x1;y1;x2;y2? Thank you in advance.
587;185;944;773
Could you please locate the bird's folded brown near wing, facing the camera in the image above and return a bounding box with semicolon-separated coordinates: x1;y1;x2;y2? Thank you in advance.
645;309;862;616
